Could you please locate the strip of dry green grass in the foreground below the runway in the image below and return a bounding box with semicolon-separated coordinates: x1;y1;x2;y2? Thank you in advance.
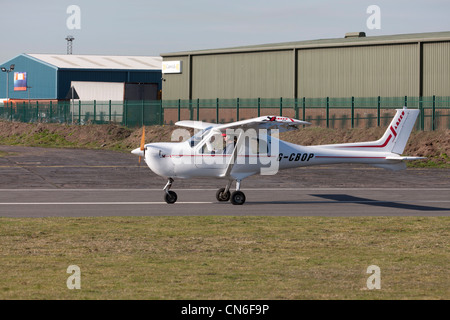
0;217;450;299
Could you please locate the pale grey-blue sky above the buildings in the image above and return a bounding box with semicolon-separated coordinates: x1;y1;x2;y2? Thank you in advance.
0;0;450;63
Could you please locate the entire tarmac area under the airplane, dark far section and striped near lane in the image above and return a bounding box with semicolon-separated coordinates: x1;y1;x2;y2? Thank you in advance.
0;146;450;217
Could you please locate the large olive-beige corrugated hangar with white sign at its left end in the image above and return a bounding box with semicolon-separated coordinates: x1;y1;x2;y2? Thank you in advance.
161;32;450;100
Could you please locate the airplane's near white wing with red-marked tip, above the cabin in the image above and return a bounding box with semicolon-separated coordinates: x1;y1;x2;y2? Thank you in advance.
214;116;311;132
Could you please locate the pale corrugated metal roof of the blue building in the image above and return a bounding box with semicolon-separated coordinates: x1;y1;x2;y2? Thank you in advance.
26;54;162;70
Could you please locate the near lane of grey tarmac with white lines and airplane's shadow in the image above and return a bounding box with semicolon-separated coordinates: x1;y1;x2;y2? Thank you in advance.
0;188;450;217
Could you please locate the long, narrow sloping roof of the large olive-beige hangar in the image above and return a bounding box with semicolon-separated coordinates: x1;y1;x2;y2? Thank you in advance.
161;31;450;57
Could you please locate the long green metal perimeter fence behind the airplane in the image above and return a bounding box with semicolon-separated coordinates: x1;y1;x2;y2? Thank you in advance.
0;96;450;131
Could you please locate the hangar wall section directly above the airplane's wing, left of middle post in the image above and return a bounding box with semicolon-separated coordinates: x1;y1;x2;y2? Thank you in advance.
192;50;294;99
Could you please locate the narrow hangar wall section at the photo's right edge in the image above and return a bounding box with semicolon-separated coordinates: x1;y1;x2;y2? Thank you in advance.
423;42;450;96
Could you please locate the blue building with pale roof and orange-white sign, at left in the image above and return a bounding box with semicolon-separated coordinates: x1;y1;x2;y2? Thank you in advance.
0;54;162;100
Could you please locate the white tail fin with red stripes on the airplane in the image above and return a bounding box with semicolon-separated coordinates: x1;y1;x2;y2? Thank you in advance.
327;107;420;154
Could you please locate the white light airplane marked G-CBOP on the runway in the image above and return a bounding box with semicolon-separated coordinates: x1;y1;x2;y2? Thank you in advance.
131;107;424;205
